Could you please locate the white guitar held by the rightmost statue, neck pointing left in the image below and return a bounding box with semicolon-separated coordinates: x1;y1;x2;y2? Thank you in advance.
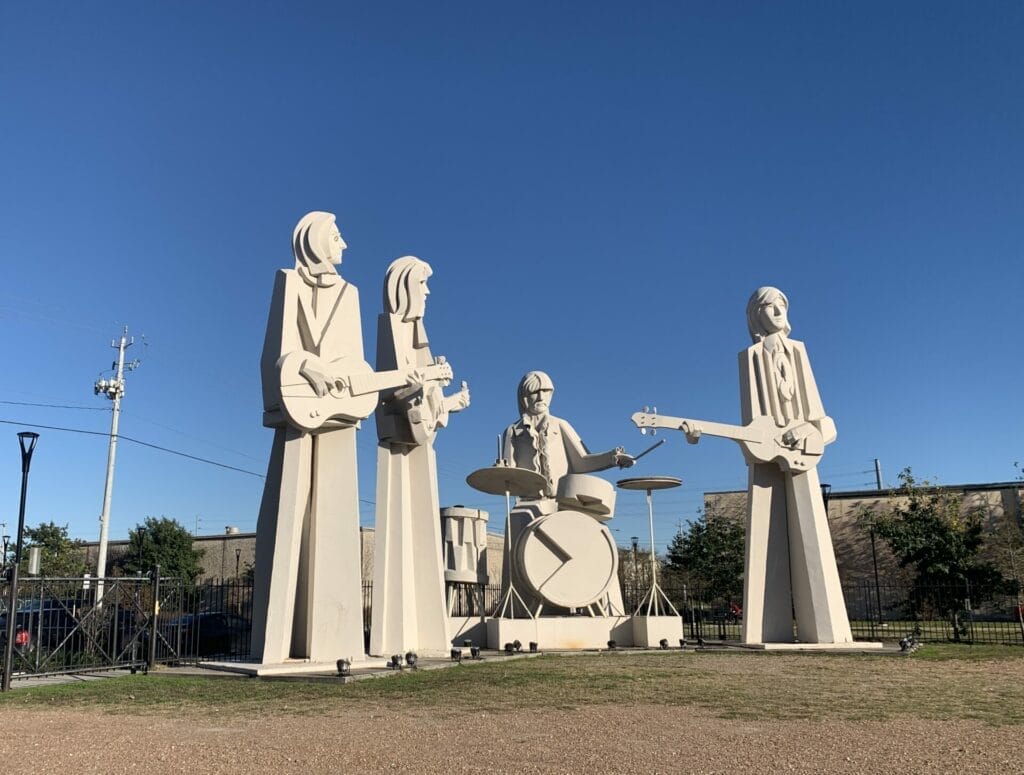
631;412;824;473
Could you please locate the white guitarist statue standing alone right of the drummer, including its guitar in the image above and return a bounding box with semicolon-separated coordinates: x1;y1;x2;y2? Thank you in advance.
633;287;853;645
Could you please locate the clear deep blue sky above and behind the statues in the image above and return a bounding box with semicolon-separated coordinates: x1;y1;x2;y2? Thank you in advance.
0;2;1024;550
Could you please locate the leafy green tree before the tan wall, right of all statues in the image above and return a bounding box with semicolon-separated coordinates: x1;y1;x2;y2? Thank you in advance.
874;468;1014;639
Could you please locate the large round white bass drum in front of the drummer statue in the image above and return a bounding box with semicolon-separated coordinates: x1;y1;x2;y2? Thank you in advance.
515;511;618;608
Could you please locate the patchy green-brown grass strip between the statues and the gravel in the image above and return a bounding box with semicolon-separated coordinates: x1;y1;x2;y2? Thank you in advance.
0;645;1024;725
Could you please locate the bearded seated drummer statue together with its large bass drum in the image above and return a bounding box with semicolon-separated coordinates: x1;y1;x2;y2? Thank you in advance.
502;372;634;615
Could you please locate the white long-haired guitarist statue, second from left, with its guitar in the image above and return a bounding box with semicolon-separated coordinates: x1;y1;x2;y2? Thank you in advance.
370;256;469;656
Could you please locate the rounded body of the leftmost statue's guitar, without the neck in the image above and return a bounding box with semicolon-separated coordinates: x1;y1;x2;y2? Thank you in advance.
279;350;377;431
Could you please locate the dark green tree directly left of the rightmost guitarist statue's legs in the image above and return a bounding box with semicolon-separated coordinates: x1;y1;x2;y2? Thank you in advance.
668;511;744;601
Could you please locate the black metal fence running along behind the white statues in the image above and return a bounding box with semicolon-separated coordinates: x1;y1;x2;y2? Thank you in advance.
0;576;1024;679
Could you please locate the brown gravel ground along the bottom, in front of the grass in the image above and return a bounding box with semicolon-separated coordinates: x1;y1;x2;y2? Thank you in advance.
0;704;1024;775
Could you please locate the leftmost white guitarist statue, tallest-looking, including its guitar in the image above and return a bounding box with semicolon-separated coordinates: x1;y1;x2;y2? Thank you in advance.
252;212;451;664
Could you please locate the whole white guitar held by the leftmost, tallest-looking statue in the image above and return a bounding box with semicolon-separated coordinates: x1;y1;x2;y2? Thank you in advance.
279;350;452;431
